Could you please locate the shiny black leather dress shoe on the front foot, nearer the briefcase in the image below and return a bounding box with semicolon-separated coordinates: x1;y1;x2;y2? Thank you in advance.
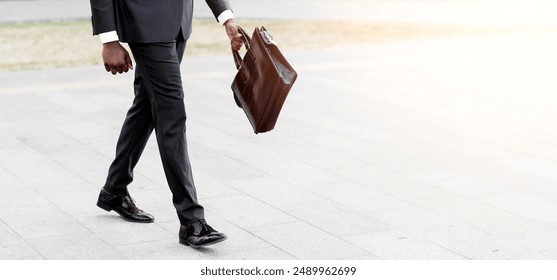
178;219;227;248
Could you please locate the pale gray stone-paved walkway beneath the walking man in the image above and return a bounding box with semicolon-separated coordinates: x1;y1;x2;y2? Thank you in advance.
0;29;557;259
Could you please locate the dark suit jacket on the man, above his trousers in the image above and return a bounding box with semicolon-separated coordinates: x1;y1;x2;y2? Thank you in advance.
90;0;231;43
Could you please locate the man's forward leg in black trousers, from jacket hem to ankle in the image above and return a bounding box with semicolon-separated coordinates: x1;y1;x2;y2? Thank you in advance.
130;41;204;225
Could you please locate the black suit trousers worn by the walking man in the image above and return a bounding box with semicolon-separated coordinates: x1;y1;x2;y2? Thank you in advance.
104;36;204;225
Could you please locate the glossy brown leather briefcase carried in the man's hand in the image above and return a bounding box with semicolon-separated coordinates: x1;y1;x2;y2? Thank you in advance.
232;27;298;134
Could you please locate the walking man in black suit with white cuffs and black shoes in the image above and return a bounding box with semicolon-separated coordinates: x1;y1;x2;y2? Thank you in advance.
90;0;243;248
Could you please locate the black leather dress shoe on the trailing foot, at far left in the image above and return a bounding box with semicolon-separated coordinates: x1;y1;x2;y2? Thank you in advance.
97;188;155;223
